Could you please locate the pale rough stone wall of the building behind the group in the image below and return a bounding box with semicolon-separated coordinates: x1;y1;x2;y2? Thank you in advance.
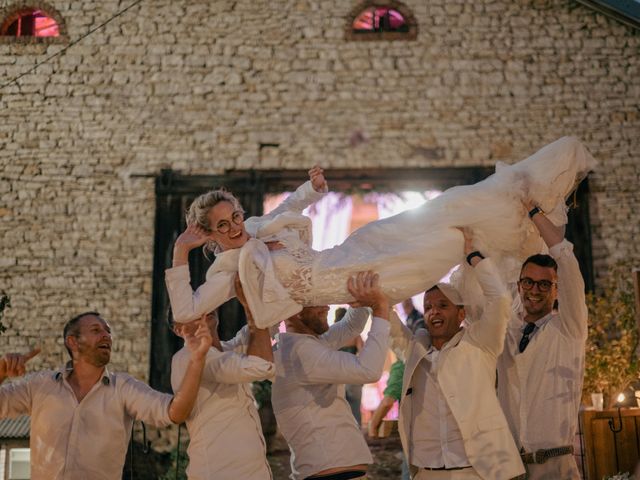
0;0;640;378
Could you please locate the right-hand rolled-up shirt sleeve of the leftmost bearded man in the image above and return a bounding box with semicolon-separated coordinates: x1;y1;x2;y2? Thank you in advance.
116;374;173;427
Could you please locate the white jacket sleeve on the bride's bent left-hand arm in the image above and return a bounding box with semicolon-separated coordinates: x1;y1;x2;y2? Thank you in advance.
165;265;236;323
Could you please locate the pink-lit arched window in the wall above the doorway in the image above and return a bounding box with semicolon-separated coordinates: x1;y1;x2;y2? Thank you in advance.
347;1;417;40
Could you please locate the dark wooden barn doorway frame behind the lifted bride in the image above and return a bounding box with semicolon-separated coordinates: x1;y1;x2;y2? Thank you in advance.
149;167;593;392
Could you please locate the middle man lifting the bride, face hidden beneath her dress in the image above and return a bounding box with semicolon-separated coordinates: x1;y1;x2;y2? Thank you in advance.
272;272;389;480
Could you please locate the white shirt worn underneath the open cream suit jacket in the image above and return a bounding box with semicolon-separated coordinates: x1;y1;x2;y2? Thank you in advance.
409;342;469;468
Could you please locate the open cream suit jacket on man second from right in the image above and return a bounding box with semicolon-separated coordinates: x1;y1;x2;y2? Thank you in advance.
391;258;525;480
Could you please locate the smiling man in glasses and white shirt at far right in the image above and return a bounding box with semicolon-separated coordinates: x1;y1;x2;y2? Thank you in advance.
498;201;587;480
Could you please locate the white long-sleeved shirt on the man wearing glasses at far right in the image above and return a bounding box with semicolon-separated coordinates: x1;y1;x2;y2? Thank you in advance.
498;240;587;465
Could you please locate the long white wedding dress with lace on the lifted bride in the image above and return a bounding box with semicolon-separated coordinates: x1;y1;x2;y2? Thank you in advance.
271;137;594;305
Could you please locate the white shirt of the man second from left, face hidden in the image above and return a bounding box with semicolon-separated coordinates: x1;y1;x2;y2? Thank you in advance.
171;326;275;480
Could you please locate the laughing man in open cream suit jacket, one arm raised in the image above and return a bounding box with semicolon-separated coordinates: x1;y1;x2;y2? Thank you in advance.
391;234;524;480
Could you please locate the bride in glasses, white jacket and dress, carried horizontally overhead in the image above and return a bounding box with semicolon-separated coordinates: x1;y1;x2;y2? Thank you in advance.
165;137;594;328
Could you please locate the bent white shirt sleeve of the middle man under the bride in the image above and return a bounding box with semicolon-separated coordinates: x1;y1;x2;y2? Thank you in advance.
296;317;389;384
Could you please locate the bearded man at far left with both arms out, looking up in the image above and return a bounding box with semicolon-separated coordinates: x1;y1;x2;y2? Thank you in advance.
0;312;211;480
